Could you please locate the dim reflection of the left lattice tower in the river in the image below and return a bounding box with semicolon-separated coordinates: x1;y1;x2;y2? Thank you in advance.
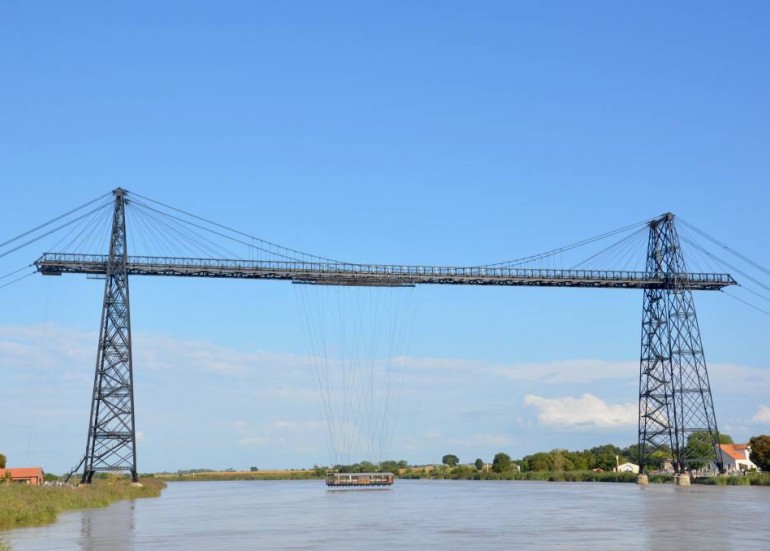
78;501;135;551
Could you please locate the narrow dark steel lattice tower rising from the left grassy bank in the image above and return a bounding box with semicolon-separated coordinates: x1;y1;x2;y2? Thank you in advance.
81;188;137;483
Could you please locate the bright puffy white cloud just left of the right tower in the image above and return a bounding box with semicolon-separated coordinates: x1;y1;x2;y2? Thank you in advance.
524;394;638;428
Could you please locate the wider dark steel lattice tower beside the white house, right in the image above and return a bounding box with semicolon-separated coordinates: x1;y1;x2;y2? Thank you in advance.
639;213;723;473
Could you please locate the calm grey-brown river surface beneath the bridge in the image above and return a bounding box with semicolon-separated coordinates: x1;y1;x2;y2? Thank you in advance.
0;480;770;551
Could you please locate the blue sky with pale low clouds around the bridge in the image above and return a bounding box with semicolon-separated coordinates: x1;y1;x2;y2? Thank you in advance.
0;1;770;472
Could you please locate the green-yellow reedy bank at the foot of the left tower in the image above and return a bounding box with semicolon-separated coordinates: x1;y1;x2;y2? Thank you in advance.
0;477;166;530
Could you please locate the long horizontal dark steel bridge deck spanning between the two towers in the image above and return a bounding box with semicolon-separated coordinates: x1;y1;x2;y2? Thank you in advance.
35;253;736;291
